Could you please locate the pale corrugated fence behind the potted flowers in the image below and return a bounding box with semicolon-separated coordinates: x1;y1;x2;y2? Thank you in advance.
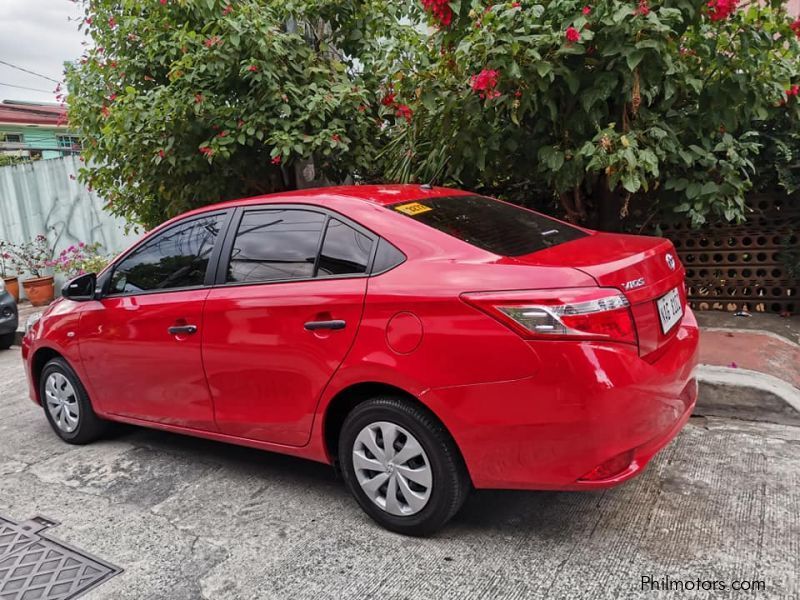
0;156;138;286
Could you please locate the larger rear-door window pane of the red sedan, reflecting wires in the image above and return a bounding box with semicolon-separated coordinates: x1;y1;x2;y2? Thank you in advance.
225;209;325;283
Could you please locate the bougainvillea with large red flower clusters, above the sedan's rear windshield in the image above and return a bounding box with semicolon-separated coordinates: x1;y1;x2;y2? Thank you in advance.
381;0;800;229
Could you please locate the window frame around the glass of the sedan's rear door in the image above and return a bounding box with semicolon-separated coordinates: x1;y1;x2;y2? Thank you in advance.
212;203;381;288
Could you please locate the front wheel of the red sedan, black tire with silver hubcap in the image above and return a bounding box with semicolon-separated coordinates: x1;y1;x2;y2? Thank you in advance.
39;358;106;444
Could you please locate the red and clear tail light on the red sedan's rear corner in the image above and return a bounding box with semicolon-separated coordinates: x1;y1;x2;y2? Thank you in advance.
461;288;636;344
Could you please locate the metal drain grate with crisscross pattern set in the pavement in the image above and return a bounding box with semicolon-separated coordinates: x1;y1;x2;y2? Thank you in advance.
0;517;122;600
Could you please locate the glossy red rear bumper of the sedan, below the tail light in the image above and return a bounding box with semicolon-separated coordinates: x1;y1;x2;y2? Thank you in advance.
425;308;699;490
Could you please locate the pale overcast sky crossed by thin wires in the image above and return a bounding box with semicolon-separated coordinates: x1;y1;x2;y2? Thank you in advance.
0;0;86;102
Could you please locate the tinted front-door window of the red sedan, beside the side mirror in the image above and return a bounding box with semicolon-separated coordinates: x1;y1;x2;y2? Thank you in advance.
110;214;224;294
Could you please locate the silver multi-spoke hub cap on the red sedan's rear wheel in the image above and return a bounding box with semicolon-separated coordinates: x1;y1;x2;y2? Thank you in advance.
353;421;433;516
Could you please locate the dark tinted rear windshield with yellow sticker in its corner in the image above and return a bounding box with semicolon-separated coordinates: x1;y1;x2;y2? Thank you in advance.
389;196;587;256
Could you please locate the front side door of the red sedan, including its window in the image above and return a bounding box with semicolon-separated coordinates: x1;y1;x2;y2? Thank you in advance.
80;211;230;430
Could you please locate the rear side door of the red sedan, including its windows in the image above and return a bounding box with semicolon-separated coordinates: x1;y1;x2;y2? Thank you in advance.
203;206;376;446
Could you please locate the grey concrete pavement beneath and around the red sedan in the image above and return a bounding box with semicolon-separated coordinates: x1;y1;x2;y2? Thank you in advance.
0;350;800;600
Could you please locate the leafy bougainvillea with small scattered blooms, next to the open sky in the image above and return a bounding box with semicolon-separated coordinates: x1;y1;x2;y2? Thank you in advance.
67;0;410;226
